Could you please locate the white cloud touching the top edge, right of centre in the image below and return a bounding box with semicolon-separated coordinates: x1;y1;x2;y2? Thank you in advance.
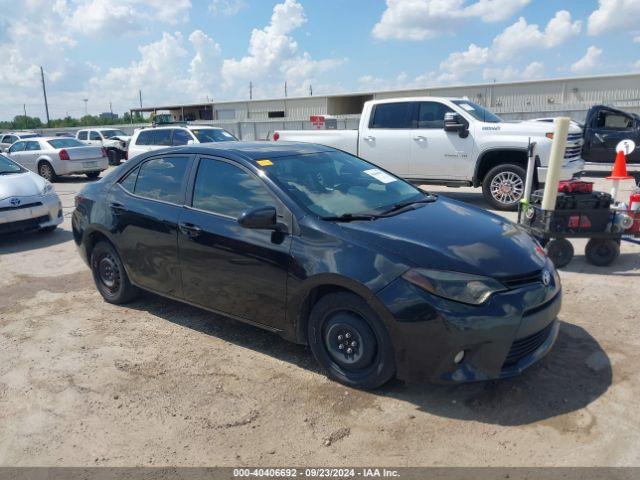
372;0;530;40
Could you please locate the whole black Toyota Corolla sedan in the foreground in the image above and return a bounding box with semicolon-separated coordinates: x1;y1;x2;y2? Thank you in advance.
73;142;561;388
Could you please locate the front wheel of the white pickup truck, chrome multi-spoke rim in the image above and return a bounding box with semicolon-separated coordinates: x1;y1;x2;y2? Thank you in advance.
482;163;527;211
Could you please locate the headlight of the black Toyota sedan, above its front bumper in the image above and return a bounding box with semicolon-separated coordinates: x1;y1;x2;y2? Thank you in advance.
402;268;507;305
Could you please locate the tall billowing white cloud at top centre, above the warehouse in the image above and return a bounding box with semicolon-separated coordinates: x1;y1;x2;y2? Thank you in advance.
222;0;344;95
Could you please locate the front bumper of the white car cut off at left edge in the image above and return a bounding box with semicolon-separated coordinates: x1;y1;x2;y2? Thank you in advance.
0;194;63;234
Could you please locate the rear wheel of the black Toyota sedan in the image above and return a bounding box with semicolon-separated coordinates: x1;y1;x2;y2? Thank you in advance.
91;241;140;305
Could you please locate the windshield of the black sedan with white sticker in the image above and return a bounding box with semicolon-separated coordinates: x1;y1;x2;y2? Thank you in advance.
257;151;425;218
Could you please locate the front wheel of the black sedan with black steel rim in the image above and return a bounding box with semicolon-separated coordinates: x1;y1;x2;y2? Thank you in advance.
308;292;395;390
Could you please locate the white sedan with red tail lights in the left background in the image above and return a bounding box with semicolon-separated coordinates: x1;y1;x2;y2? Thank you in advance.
7;137;109;182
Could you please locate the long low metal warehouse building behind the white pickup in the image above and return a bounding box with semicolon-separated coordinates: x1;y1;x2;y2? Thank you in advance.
131;73;640;140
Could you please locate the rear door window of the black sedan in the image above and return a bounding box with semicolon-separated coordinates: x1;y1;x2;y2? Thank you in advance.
133;156;189;204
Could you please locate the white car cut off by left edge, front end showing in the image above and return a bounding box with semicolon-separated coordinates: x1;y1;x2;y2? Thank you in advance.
0;155;63;234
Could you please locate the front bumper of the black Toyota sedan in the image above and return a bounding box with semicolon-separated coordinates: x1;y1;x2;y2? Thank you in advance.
377;268;562;383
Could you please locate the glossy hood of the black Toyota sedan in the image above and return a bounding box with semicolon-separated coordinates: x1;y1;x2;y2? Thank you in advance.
339;197;546;278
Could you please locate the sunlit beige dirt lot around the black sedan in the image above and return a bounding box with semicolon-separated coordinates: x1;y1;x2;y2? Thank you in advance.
0;172;640;466
